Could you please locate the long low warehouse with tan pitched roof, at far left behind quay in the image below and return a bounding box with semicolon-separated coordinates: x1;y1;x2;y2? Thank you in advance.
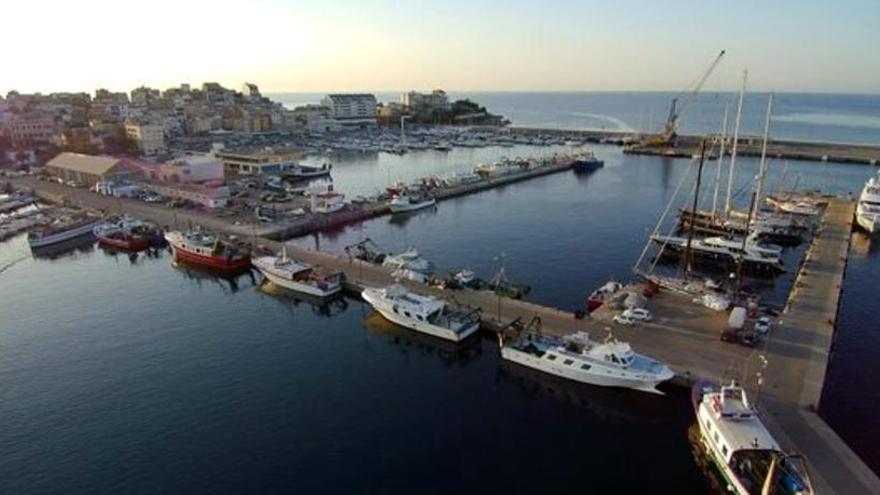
46;151;141;187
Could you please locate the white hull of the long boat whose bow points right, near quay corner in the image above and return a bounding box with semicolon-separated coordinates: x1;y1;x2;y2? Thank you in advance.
501;346;661;394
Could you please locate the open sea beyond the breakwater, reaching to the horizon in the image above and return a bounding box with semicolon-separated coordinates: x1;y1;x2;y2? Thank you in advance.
268;91;880;144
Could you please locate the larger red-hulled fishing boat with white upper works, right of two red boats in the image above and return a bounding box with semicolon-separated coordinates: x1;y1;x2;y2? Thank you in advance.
165;231;251;272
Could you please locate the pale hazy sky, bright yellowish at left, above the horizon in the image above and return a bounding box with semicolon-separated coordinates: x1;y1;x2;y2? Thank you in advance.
0;0;880;94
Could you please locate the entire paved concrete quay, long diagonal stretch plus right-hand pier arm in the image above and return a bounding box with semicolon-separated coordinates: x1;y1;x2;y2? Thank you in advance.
13;177;880;494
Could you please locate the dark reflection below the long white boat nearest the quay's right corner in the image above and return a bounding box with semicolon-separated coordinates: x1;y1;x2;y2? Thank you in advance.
497;359;683;423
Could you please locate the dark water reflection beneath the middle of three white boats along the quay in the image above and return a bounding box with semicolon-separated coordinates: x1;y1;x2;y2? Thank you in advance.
364;314;483;367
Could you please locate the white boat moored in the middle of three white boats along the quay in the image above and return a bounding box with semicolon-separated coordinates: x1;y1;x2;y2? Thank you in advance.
361;284;480;342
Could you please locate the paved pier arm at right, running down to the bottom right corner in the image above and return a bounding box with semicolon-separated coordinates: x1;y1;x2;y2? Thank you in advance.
759;200;880;494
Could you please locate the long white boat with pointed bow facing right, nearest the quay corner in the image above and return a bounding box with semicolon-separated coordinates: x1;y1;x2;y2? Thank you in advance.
500;332;674;393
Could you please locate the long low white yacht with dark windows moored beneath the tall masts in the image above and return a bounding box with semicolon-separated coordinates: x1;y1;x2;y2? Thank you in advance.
651;232;785;271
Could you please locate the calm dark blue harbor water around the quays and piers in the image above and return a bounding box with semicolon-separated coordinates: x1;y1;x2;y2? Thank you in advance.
0;146;880;493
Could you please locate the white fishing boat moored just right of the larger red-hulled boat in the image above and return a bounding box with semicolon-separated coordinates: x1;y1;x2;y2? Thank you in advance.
251;248;342;297
